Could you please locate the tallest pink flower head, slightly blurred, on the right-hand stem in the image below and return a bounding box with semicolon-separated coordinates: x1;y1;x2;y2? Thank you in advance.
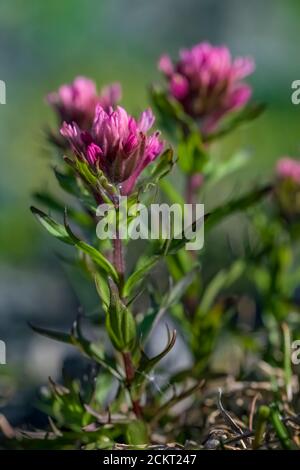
158;42;254;133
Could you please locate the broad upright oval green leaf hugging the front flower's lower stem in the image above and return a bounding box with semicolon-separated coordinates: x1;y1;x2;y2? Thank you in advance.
106;280;136;352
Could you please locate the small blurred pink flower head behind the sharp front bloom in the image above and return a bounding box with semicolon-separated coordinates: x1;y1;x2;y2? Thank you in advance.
47;77;121;129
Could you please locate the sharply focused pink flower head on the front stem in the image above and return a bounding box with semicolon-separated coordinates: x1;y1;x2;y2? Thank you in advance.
61;104;163;194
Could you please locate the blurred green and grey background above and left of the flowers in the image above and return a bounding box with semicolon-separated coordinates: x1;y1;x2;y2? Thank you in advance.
0;0;300;424
